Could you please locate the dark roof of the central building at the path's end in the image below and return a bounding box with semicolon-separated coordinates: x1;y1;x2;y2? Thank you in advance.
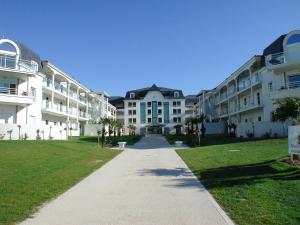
125;84;184;99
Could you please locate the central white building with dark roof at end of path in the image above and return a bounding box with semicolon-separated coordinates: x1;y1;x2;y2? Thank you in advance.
111;84;185;135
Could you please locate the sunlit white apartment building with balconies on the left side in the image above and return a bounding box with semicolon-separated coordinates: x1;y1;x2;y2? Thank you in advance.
0;39;116;139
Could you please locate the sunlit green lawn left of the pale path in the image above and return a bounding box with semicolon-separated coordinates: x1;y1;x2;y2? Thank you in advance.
0;138;120;224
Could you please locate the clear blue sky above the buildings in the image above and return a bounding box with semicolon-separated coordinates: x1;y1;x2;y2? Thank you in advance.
0;0;300;95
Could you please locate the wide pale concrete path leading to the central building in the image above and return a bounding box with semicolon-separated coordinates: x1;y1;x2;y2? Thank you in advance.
21;136;233;225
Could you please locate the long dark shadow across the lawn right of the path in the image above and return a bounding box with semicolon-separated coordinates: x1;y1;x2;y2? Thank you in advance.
194;160;300;189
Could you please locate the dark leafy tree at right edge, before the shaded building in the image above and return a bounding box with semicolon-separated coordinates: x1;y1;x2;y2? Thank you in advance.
273;97;300;124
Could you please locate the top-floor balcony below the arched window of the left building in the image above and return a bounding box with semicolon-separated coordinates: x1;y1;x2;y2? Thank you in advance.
0;53;38;73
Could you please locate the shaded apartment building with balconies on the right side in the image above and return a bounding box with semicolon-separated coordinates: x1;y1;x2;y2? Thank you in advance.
197;30;300;136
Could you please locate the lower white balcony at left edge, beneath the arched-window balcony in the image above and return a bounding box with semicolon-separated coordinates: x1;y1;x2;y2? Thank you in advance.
0;87;35;106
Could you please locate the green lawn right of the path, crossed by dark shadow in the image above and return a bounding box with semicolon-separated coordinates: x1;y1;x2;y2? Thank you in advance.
177;139;300;225
